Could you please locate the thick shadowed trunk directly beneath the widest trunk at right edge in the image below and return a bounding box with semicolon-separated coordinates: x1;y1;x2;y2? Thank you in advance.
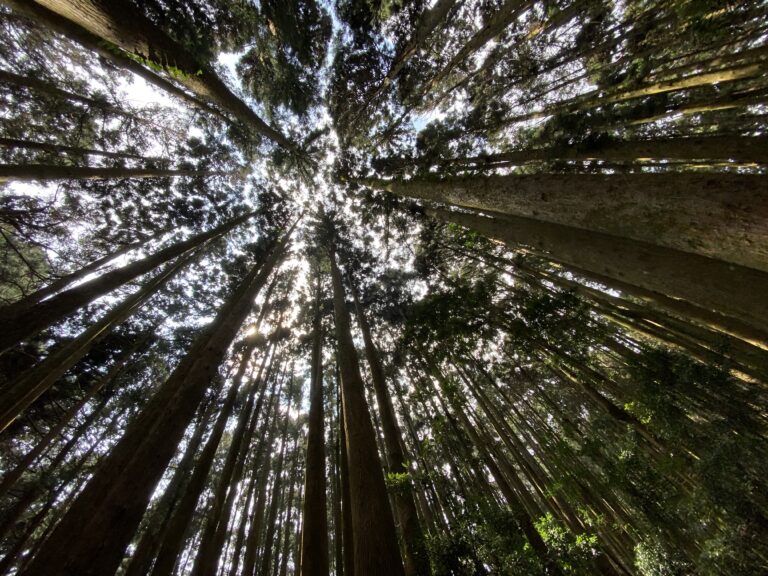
427;209;768;349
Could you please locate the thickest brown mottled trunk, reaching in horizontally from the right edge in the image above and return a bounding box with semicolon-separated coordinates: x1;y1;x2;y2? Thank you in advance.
360;174;768;272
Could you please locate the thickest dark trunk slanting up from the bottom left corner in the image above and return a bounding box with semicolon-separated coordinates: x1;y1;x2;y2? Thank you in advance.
24;231;290;576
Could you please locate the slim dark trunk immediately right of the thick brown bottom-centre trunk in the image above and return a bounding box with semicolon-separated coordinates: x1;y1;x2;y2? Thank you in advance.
350;278;431;576
